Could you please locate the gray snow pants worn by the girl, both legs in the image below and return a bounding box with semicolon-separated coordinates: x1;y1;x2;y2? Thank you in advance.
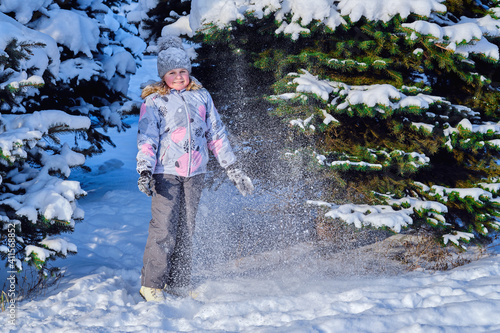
141;174;205;289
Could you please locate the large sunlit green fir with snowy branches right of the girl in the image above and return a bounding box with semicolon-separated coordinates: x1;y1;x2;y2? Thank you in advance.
149;0;500;245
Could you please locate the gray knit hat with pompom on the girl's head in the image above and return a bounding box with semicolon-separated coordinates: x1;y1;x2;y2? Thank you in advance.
157;35;191;79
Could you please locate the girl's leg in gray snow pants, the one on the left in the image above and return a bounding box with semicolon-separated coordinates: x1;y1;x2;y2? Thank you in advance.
141;175;183;289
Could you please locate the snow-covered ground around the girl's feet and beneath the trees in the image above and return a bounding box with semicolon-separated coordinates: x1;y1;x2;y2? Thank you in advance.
0;58;500;333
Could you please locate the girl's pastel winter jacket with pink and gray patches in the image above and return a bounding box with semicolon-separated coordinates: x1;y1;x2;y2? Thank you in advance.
137;88;236;177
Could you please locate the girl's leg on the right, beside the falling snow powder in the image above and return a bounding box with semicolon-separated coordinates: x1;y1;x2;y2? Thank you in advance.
167;175;205;288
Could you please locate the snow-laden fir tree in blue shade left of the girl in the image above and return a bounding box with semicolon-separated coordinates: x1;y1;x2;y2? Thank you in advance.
0;0;145;274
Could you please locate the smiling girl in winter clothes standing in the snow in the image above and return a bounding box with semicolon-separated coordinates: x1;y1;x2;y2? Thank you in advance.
137;36;253;301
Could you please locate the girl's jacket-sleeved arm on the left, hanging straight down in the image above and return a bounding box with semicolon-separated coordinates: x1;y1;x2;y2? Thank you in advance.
137;97;160;174
